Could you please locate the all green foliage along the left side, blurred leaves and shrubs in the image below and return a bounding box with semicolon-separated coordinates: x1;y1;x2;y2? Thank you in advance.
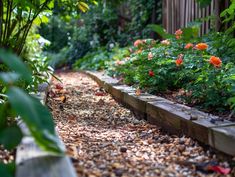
0;0;96;176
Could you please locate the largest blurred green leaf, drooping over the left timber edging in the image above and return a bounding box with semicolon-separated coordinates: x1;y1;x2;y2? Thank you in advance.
7;87;64;154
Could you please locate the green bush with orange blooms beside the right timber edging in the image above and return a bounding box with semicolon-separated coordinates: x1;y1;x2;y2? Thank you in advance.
108;29;235;112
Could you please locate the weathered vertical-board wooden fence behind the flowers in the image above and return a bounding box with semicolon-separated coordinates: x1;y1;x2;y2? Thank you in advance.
162;0;229;35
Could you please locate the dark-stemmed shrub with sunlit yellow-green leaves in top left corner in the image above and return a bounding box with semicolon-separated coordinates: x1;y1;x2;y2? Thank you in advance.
0;0;53;54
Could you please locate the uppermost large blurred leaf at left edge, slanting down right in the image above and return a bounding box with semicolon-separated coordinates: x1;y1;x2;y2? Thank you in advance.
0;49;32;82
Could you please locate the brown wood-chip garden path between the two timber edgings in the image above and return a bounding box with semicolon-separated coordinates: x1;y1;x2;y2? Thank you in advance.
48;72;232;177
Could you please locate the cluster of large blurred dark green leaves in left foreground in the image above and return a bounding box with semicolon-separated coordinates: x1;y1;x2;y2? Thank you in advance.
0;49;64;176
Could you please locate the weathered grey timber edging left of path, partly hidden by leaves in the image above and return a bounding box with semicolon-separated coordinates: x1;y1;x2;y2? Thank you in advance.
15;79;77;177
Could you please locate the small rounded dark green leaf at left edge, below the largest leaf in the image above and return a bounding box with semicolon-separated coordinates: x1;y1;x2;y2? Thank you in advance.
0;126;23;150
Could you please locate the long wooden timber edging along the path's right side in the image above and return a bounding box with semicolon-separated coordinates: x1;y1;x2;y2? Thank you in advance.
83;71;235;156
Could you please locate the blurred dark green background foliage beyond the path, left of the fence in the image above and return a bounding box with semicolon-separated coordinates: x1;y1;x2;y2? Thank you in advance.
40;0;161;67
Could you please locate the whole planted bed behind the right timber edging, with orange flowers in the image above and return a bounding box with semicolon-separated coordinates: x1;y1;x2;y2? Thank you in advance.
74;32;235;121
